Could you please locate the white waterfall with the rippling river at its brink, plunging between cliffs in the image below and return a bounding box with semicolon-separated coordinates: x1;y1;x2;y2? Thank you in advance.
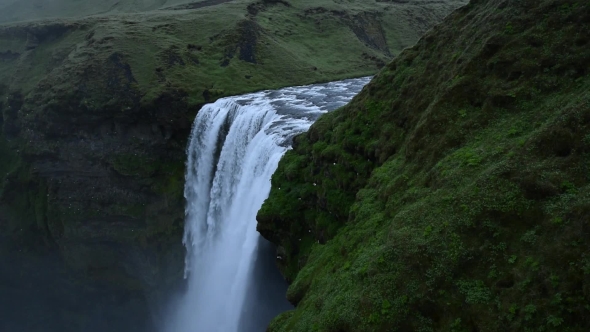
167;78;369;332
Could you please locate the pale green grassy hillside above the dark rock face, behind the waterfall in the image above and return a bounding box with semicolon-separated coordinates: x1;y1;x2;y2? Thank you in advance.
0;0;463;107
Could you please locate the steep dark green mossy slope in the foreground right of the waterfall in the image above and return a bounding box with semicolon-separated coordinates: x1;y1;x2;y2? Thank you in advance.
258;0;590;331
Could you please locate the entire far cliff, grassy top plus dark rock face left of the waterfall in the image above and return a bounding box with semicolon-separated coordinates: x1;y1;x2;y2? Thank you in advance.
0;0;464;331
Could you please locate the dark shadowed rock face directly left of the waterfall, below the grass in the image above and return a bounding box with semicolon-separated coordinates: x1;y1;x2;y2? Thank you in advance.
0;53;191;331
